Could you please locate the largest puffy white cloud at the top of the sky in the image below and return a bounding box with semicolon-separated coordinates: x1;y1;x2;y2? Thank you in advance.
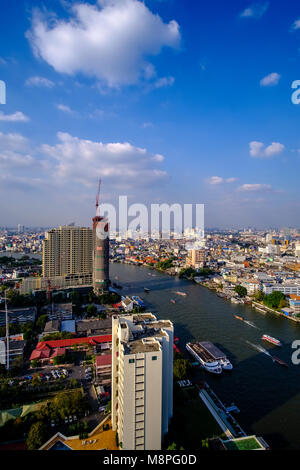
26;0;180;87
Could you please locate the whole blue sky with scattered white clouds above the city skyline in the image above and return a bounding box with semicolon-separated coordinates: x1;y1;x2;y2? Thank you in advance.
0;0;300;227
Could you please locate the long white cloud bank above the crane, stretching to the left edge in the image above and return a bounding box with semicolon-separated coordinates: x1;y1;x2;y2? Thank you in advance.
0;132;168;194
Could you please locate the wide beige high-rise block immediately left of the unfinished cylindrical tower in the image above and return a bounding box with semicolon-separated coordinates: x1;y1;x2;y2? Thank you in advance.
43;226;93;278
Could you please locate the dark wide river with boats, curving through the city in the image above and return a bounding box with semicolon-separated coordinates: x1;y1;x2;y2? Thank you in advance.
111;263;300;450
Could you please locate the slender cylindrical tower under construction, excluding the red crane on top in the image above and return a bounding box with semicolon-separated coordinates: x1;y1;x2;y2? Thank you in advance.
93;216;109;295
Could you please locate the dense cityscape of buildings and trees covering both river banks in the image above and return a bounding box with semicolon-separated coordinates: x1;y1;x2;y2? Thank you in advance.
0;224;300;450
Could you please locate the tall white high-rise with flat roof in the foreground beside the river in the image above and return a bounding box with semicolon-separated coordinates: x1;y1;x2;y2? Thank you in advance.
112;313;174;450
